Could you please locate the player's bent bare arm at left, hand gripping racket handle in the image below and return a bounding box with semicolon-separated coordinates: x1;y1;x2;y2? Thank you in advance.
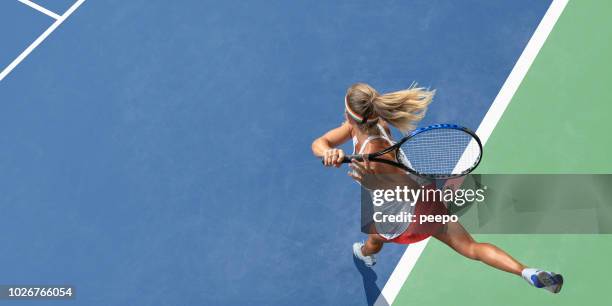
312;122;351;167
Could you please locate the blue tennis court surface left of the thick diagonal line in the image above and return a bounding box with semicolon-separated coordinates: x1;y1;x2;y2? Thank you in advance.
0;0;550;306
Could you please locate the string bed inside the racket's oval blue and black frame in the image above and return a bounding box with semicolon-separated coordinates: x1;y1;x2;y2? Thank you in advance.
400;129;481;175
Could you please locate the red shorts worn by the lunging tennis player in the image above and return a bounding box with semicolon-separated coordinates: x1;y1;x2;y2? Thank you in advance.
379;185;448;244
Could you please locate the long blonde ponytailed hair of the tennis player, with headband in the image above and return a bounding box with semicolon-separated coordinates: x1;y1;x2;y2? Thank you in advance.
345;83;435;134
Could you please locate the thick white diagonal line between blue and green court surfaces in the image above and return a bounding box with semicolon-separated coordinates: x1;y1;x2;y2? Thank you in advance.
375;0;569;306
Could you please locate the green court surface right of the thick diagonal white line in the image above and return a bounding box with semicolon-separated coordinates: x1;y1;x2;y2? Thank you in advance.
393;0;612;306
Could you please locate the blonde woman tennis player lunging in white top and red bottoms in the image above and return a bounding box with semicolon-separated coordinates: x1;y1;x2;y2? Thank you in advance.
312;83;563;293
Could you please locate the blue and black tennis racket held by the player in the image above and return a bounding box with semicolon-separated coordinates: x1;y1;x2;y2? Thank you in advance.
342;124;482;179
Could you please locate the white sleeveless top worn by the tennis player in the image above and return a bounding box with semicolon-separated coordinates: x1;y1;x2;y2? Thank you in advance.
353;124;414;240
